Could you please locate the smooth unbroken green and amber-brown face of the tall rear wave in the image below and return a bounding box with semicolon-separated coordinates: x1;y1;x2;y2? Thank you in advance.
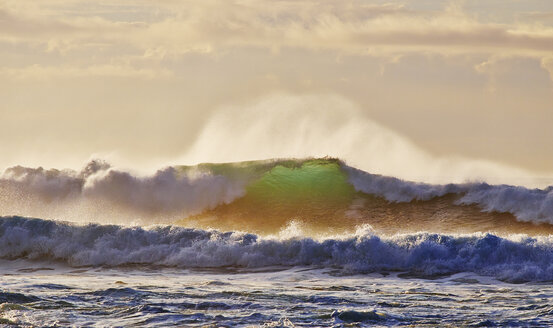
178;158;553;235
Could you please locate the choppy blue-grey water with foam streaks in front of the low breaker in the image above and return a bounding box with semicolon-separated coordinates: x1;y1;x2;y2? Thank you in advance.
0;262;553;327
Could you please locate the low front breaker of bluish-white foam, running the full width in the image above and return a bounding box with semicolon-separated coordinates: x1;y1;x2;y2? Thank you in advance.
0;217;553;282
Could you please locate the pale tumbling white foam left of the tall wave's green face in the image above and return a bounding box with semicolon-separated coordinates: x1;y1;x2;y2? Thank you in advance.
0;161;244;222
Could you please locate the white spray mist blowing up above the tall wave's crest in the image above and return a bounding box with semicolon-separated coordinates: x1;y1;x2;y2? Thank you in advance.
180;94;553;188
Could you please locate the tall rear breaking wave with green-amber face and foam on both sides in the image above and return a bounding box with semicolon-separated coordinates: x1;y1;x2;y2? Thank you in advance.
0;158;553;234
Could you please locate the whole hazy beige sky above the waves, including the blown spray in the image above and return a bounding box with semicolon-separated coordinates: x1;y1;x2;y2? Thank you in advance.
0;0;553;181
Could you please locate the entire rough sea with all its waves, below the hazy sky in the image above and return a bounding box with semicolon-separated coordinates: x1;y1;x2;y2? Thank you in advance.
0;158;553;327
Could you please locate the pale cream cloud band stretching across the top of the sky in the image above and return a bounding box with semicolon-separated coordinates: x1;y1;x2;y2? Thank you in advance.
0;0;553;80
